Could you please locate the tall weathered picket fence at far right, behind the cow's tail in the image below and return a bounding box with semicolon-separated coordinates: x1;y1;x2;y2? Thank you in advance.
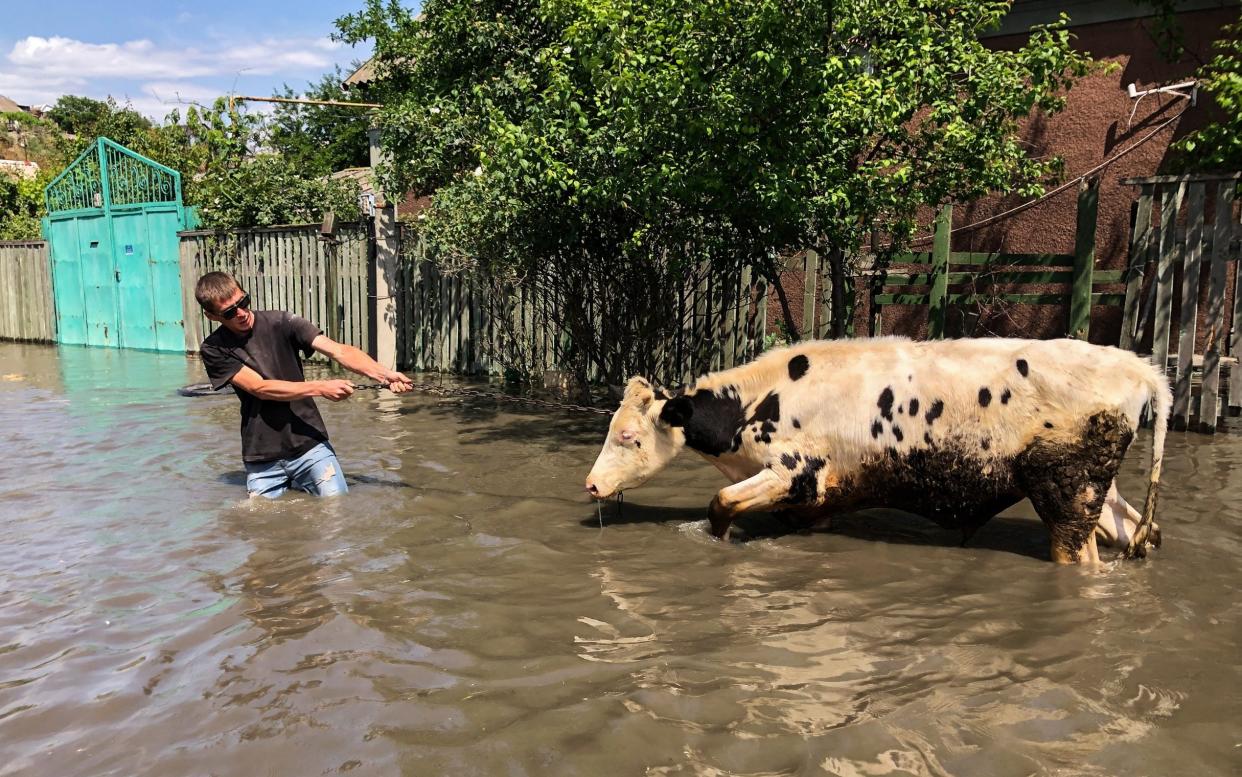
1120;173;1242;432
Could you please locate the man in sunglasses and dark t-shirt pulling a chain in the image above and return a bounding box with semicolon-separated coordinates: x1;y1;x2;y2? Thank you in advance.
194;273;412;499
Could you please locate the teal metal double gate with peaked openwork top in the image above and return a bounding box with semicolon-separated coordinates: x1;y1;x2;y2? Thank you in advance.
43;138;195;351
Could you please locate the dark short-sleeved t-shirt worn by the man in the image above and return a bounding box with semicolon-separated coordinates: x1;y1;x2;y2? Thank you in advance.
201;310;328;463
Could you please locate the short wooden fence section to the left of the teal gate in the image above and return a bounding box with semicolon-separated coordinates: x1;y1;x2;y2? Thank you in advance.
0;241;56;343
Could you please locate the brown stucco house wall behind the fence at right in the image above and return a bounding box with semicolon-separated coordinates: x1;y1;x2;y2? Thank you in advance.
784;6;1238;344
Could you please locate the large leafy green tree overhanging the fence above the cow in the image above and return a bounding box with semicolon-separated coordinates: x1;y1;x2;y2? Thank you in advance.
338;0;1088;377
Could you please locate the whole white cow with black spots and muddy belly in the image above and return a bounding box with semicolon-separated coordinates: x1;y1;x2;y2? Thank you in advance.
586;338;1171;564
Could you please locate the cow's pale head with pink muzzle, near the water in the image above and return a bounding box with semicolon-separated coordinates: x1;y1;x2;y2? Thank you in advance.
586;377;686;499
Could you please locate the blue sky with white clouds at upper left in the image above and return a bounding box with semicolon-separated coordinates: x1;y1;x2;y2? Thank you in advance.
0;0;402;119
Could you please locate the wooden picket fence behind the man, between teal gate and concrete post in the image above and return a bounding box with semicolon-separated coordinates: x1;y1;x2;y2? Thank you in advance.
179;223;373;353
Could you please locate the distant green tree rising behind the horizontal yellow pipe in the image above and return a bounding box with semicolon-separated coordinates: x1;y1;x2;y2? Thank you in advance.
267;62;370;175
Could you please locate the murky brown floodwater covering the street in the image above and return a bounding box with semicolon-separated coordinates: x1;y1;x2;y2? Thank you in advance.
0;344;1242;777
